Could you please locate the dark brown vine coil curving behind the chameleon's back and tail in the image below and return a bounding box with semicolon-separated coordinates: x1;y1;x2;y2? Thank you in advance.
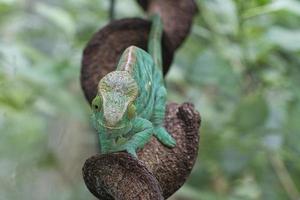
80;18;174;103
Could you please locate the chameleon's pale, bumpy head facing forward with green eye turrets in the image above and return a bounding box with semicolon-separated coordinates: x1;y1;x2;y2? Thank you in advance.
92;71;138;133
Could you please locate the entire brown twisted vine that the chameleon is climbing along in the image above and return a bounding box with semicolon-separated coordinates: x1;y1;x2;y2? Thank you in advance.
81;0;200;200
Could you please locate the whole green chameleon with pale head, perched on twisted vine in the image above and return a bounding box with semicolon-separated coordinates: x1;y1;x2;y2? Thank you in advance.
92;15;176;157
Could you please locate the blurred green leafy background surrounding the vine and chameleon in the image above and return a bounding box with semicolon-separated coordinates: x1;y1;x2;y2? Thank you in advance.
0;0;300;200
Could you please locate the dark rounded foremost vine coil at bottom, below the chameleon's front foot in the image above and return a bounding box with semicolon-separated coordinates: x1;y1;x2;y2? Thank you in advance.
83;152;163;200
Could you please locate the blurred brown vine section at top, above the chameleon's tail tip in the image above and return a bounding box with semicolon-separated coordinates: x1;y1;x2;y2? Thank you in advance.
137;0;198;50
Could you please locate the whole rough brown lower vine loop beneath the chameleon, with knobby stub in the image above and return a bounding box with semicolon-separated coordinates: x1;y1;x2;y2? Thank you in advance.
83;103;200;200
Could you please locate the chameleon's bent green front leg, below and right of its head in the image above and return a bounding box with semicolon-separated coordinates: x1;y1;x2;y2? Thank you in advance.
116;117;153;158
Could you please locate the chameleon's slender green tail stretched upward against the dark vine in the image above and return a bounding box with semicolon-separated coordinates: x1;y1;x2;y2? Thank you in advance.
148;14;163;69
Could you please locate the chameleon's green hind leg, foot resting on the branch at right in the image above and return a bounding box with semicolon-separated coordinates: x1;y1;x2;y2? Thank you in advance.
151;86;176;147
